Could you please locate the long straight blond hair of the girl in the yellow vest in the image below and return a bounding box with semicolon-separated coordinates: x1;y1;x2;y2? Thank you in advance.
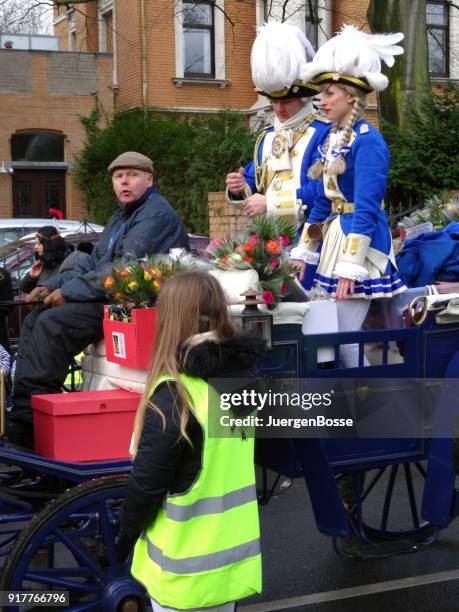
133;271;236;455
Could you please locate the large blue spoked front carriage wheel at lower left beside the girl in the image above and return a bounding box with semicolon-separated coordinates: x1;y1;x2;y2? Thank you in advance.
0;476;146;612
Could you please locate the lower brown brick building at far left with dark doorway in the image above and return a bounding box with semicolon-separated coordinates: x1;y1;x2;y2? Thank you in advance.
0;35;113;220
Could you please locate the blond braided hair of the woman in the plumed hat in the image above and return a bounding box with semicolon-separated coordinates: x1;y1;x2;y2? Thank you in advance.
308;82;367;179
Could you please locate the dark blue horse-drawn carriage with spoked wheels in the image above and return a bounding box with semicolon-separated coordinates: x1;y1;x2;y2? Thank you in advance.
0;294;459;612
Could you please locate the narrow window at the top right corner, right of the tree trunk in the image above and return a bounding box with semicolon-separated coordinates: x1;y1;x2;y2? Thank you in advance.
426;2;449;77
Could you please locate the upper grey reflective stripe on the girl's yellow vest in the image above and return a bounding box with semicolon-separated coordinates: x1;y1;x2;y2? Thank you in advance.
165;485;257;521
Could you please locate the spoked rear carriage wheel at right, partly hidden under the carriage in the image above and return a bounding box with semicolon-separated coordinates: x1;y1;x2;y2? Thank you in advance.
337;461;438;556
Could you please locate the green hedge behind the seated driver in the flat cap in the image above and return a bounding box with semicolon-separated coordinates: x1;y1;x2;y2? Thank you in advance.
74;110;254;233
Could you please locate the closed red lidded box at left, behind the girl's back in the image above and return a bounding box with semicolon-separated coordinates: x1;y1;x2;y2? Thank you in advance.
32;389;142;461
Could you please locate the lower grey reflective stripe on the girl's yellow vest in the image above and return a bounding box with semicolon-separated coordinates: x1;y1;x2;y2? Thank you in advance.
140;532;260;574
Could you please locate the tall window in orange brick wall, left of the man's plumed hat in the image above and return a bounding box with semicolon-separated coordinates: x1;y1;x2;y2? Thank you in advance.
183;2;215;78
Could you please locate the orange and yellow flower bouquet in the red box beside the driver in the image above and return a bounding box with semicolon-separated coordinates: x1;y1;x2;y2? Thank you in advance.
102;255;190;308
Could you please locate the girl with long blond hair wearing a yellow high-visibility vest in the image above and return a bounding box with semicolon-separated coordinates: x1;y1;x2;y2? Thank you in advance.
118;271;264;612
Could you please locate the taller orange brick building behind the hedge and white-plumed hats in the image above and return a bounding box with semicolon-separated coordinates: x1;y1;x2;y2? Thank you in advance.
47;0;378;223
